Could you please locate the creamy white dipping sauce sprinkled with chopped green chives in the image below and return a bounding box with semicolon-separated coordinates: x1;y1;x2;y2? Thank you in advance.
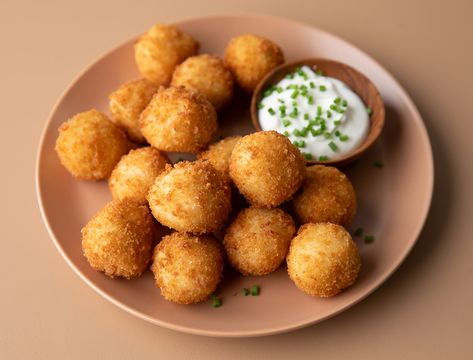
258;66;370;161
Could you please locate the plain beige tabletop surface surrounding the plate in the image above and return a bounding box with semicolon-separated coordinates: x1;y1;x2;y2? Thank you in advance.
0;0;473;359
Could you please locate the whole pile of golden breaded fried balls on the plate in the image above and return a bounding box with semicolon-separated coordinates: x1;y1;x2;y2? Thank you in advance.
56;24;361;304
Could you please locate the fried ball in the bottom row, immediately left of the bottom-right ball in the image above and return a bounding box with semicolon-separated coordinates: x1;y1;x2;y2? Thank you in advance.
223;207;296;276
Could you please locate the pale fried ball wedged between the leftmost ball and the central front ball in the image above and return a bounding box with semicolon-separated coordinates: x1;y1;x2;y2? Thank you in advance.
108;146;170;201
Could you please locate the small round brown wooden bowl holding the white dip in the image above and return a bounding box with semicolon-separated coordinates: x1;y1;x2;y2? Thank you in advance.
251;59;385;166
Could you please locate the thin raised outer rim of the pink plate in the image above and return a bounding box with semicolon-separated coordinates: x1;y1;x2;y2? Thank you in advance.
34;13;435;338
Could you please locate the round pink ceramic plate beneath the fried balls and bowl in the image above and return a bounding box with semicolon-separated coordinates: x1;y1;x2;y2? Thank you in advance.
36;15;433;337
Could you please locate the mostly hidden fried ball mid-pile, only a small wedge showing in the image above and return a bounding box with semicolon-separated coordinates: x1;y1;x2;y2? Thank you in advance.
197;136;241;179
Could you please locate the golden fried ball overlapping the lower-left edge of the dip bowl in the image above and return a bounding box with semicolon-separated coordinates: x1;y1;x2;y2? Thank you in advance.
230;131;306;208
